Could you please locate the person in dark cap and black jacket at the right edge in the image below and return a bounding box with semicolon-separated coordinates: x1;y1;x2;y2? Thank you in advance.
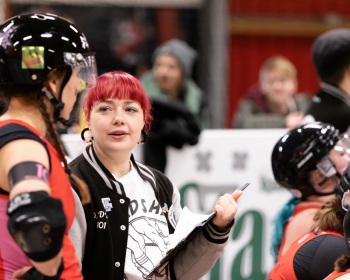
304;28;350;132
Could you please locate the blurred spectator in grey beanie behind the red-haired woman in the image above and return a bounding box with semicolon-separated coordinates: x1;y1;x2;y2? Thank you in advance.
140;39;208;172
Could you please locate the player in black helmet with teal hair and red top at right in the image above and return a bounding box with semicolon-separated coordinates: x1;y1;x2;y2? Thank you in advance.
271;123;350;260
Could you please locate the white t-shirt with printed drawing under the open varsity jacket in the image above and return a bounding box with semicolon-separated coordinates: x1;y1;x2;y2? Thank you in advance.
117;165;175;280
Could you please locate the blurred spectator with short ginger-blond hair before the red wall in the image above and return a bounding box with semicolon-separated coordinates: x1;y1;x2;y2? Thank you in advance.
233;56;311;129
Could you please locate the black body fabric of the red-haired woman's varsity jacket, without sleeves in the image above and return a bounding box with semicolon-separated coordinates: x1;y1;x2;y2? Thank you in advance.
69;155;174;280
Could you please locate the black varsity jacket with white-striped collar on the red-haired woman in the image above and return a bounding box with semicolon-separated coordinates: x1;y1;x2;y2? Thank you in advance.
69;145;230;280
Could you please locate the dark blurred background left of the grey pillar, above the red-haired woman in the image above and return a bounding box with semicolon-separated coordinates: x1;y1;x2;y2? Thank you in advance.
11;2;198;79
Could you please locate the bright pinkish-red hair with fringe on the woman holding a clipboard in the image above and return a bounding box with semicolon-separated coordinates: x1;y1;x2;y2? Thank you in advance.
84;71;153;133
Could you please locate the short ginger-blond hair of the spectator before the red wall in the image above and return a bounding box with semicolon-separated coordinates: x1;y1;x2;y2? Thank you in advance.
259;56;297;81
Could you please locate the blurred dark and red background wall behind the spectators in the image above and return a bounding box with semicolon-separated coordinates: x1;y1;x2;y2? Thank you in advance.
5;0;350;128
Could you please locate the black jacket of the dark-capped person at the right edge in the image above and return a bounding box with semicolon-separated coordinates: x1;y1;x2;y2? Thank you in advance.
305;89;350;133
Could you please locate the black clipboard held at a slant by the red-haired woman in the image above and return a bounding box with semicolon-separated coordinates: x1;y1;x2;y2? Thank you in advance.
147;212;216;279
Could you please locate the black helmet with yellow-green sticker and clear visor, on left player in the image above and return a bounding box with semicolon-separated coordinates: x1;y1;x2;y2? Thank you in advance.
0;13;97;123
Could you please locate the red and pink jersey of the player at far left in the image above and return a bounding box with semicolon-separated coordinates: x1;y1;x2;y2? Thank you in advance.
0;120;83;280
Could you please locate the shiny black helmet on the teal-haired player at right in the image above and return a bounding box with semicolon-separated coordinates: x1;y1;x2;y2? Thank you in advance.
271;122;340;198
